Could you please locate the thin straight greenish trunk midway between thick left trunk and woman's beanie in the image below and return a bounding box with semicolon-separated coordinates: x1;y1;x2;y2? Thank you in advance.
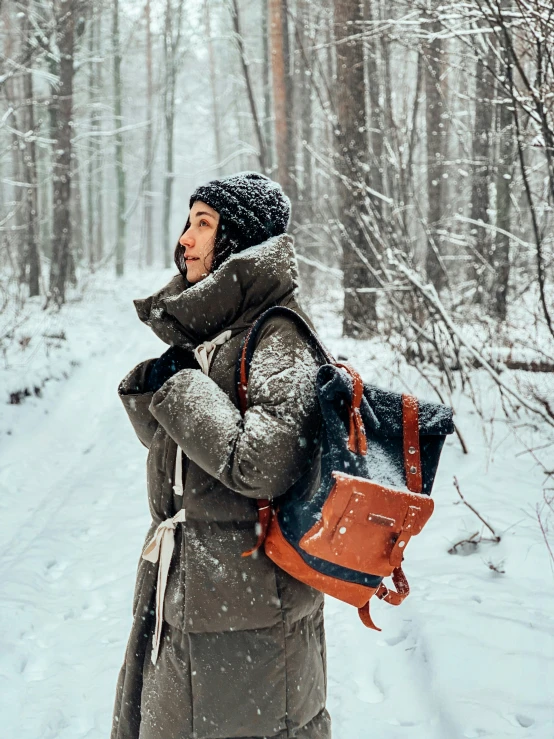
112;0;126;277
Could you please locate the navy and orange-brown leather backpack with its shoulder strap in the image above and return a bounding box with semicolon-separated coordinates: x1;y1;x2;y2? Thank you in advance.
237;306;454;631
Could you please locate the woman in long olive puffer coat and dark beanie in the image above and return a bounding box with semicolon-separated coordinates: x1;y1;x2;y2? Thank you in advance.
111;172;330;739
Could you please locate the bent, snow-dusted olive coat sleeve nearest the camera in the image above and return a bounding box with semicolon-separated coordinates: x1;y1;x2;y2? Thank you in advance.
150;318;320;498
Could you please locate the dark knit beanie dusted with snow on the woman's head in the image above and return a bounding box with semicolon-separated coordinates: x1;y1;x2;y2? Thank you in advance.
189;172;290;248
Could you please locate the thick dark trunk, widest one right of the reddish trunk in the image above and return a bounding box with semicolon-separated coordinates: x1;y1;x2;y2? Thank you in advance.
335;0;377;337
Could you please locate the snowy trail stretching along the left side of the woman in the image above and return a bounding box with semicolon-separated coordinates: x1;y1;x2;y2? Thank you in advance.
0;290;159;739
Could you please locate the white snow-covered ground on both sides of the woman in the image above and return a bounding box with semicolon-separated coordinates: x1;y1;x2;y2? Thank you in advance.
0;272;554;739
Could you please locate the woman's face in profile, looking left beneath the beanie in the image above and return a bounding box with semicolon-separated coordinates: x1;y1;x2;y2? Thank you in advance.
179;200;219;282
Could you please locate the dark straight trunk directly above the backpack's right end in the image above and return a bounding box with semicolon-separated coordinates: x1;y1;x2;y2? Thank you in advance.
424;11;445;290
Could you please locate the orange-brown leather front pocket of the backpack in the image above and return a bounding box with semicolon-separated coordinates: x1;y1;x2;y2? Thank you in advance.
299;472;434;577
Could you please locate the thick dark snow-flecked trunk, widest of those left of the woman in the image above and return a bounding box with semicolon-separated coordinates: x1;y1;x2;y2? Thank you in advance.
49;0;75;305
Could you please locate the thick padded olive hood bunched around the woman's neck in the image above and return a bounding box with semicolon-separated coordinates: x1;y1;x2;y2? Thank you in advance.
133;233;298;346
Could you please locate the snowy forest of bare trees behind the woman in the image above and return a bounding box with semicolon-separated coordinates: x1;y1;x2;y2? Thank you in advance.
0;0;554;425
